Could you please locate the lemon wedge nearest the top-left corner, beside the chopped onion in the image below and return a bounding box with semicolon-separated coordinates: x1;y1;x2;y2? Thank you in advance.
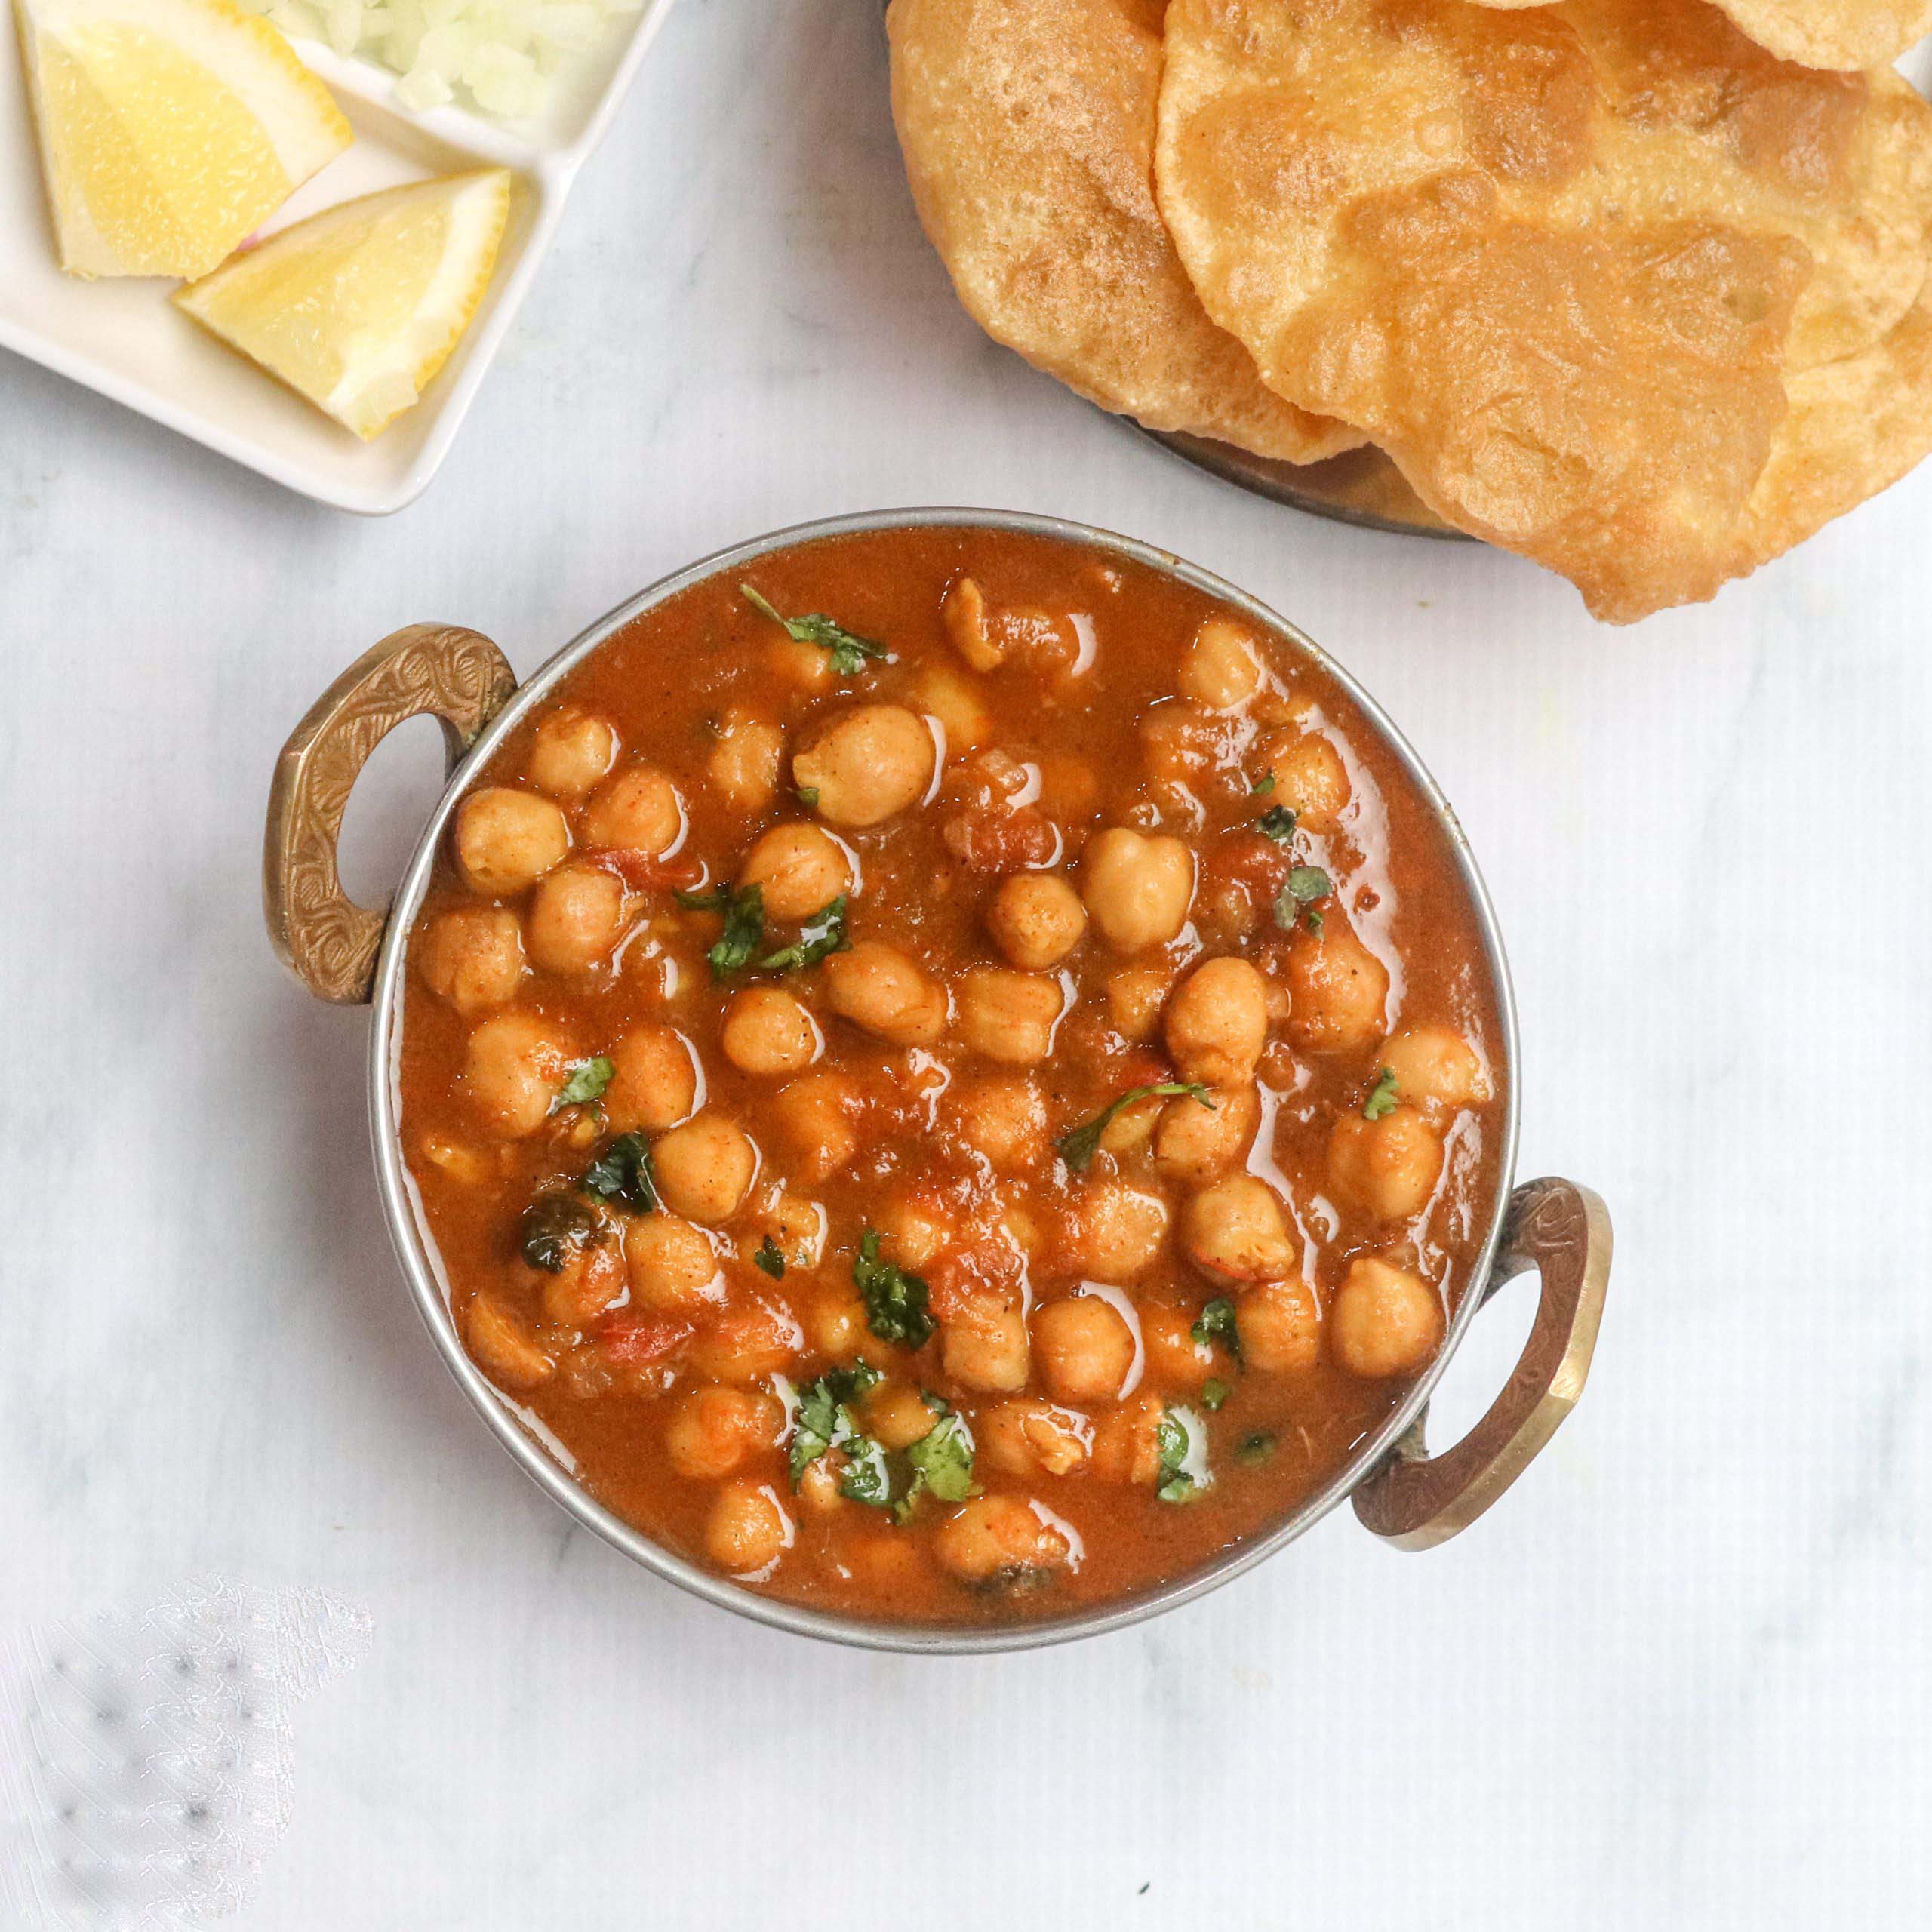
14;0;352;276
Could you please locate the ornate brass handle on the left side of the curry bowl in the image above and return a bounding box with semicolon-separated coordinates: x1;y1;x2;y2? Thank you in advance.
261;624;516;1007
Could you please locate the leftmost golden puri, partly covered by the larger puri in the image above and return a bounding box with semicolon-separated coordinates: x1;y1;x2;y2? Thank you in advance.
887;0;1362;462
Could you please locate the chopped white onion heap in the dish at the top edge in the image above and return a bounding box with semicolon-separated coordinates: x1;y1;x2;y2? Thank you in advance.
242;0;643;120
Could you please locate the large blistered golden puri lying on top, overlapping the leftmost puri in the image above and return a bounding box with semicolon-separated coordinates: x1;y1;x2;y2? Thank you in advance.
1157;0;1932;622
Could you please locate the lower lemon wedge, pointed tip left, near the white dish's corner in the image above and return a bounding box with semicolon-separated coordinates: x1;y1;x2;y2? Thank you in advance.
174;168;510;441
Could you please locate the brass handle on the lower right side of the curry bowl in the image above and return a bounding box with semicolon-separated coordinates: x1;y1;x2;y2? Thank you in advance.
1355;1180;1609;1549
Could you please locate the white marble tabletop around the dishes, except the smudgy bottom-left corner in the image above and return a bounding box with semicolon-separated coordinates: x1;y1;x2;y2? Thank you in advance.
0;0;1932;1932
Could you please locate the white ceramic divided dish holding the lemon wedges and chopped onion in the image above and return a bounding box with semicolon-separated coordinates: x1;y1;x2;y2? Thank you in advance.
0;0;670;516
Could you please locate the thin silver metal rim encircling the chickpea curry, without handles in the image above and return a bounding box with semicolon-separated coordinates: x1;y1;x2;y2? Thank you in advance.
367;506;1522;1656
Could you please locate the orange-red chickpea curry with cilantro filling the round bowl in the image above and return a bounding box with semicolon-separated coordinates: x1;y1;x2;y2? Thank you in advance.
400;529;1507;1623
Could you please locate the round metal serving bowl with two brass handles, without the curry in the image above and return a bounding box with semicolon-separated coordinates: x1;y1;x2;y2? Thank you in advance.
265;510;1611;1652
